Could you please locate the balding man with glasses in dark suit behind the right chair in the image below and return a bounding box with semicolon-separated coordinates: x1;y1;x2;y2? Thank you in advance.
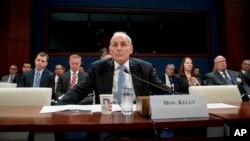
204;55;249;101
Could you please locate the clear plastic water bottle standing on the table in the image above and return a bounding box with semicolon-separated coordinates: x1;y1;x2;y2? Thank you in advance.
121;85;135;115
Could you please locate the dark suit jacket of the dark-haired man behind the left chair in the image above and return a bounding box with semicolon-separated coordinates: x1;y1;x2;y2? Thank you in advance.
19;69;55;96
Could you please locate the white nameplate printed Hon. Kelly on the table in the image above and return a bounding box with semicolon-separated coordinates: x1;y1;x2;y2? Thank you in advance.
149;95;208;119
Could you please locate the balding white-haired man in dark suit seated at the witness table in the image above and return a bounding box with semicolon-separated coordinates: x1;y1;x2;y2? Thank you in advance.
56;32;174;139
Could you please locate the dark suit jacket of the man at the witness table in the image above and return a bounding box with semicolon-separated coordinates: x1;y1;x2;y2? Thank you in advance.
59;58;174;104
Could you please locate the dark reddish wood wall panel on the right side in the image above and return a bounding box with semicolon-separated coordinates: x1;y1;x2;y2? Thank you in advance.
224;0;247;70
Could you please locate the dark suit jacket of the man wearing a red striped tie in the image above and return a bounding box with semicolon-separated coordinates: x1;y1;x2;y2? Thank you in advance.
56;71;87;95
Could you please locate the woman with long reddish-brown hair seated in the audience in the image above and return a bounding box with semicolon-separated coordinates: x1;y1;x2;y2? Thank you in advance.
179;57;202;94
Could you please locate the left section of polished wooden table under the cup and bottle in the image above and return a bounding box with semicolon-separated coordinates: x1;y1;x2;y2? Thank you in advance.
0;106;153;132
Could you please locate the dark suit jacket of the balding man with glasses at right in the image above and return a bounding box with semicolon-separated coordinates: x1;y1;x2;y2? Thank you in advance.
205;70;239;85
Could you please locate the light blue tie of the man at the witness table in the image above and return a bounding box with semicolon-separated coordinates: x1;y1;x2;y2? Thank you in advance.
117;65;125;104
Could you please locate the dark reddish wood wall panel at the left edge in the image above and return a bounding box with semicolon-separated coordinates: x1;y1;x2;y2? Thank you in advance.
0;0;31;76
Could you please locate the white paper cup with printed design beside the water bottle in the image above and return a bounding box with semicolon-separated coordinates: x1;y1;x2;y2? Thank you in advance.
99;94;113;114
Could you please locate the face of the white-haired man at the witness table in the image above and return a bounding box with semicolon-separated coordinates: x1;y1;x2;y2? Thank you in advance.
109;36;133;64
